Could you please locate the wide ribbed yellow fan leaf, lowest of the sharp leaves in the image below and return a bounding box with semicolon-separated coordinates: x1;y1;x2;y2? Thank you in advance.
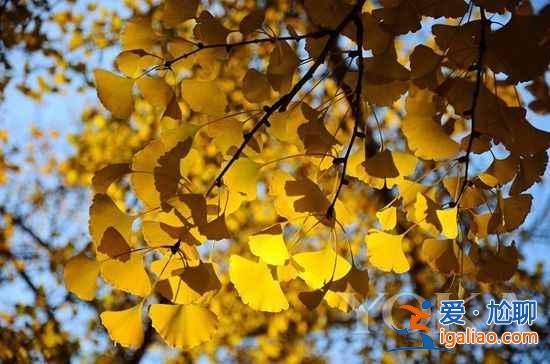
149;304;218;349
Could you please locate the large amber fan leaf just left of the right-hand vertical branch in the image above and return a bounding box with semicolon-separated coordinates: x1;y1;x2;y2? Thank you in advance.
402;90;460;161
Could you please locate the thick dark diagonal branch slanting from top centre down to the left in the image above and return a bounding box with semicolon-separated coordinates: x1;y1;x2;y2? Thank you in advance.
206;0;366;196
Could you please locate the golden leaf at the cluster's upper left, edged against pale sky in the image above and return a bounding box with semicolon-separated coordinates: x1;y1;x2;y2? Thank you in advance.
94;69;134;119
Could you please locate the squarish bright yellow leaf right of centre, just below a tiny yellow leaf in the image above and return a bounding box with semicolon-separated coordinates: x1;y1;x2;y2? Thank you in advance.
365;230;410;273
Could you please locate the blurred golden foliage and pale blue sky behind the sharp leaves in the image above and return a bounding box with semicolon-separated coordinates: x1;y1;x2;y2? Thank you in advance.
0;0;550;362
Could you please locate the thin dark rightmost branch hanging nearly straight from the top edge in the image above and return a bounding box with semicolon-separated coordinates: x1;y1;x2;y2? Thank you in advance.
455;7;487;205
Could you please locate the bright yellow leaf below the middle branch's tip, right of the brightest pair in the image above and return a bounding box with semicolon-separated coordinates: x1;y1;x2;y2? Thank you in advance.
292;246;351;289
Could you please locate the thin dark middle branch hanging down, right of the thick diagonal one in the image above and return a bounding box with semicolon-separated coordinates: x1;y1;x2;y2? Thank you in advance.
326;14;364;219
